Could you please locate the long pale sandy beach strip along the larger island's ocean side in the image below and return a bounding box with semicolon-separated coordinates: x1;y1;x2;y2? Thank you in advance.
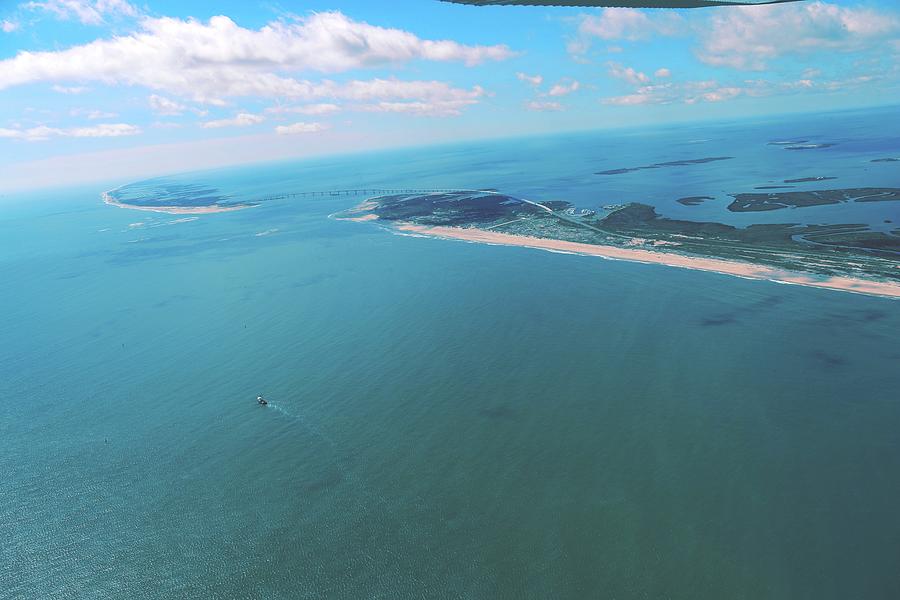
396;223;900;298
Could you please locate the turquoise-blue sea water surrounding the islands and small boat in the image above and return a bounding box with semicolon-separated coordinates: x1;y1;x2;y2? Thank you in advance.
0;110;900;599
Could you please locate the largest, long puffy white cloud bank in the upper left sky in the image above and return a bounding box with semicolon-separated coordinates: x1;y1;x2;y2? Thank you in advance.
0;12;513;105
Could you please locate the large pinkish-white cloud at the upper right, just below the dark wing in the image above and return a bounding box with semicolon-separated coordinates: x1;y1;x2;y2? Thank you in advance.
697;2;900;70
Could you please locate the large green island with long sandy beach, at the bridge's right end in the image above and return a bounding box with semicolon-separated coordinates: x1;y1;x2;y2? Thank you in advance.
333;190;900;298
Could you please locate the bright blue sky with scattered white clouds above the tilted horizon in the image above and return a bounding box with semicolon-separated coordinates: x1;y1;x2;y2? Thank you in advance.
0;0;900;193
